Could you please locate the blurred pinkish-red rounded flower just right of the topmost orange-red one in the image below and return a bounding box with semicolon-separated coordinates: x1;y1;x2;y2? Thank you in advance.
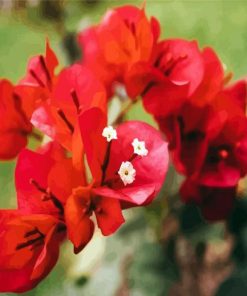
126;39;204;108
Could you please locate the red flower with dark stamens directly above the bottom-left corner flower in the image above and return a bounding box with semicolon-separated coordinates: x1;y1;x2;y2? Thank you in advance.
15;142;85;219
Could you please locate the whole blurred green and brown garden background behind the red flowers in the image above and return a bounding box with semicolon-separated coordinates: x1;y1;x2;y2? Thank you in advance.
0;0;247;296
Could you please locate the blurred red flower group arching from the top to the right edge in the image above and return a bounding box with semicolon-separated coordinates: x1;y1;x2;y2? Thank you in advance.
78;6;247;220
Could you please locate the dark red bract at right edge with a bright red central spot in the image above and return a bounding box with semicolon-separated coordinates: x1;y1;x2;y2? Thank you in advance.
199;117;247;186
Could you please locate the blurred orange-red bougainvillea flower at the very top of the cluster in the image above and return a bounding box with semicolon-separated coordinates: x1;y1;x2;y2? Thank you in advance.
78;6;160;94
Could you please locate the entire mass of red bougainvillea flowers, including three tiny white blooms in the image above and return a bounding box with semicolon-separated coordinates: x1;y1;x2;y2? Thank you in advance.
0;2;247;292
